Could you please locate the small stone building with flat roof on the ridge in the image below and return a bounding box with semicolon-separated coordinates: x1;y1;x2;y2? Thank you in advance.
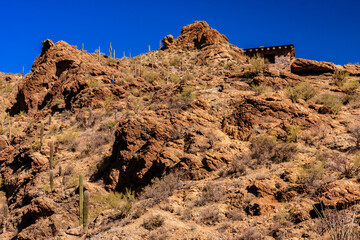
244;44;295;69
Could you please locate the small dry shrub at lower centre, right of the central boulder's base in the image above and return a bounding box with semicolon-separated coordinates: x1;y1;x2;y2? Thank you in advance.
195;182;225;206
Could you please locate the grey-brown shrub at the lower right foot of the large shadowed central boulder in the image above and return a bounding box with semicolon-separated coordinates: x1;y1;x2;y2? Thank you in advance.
139;172;183;206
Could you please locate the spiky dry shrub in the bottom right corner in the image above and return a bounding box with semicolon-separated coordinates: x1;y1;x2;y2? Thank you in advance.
314;207;359;240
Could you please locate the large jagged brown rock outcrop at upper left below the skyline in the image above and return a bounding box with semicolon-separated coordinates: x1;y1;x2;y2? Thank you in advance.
10;40;123;115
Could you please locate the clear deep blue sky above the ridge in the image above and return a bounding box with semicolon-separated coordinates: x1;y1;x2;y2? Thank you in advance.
0;0;360;73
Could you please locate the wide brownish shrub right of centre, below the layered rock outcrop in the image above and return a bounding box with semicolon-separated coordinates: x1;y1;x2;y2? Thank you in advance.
250;134;297;164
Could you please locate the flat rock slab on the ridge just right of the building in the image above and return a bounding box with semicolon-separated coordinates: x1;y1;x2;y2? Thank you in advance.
291;58;336;75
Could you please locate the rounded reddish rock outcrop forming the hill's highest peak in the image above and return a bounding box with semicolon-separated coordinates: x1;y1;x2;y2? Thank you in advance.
163;21;229;49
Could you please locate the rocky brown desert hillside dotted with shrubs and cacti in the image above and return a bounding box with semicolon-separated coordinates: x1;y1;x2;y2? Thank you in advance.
0;21;360;239
